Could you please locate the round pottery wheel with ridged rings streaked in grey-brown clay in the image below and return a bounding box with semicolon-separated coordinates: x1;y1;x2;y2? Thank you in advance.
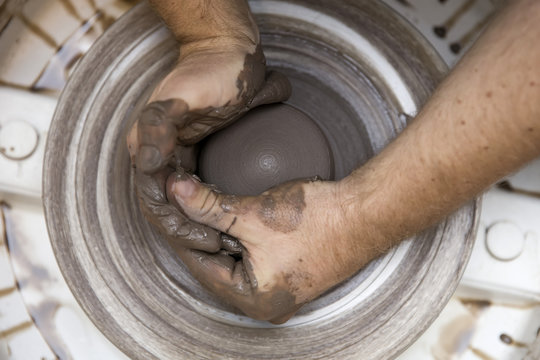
43;0;477;359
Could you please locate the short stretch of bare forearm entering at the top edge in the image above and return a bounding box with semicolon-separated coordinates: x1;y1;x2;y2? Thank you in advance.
150;0;259;48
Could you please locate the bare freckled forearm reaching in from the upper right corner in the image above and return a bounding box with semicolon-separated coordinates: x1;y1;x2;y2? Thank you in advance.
339;0;540;255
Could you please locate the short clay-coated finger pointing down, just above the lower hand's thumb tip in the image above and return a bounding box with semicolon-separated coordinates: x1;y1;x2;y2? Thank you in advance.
136;99;188;174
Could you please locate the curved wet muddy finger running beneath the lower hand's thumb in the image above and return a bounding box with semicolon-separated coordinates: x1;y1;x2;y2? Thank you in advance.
135;170;221;252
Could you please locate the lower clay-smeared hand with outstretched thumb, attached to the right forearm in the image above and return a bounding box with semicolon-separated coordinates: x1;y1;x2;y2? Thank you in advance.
158;172;375;323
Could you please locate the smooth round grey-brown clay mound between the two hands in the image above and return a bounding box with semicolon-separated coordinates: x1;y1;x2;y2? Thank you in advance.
199;104;334;195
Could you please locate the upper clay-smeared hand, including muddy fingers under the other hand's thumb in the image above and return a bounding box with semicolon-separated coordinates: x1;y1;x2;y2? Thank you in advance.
127;39;290;251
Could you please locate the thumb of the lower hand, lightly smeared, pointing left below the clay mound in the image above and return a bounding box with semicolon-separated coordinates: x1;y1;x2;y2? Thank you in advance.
167;171;253;239
